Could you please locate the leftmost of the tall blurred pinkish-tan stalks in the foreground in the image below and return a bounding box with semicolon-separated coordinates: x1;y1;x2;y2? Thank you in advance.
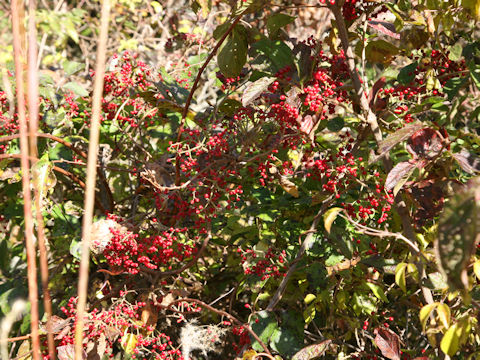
11;0;40;360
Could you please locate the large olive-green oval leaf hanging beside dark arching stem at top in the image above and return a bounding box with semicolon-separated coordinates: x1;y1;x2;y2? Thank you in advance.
217;27;248;78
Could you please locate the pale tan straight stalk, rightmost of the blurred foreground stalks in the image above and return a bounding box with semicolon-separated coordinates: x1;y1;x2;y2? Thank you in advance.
75;0;111;359
